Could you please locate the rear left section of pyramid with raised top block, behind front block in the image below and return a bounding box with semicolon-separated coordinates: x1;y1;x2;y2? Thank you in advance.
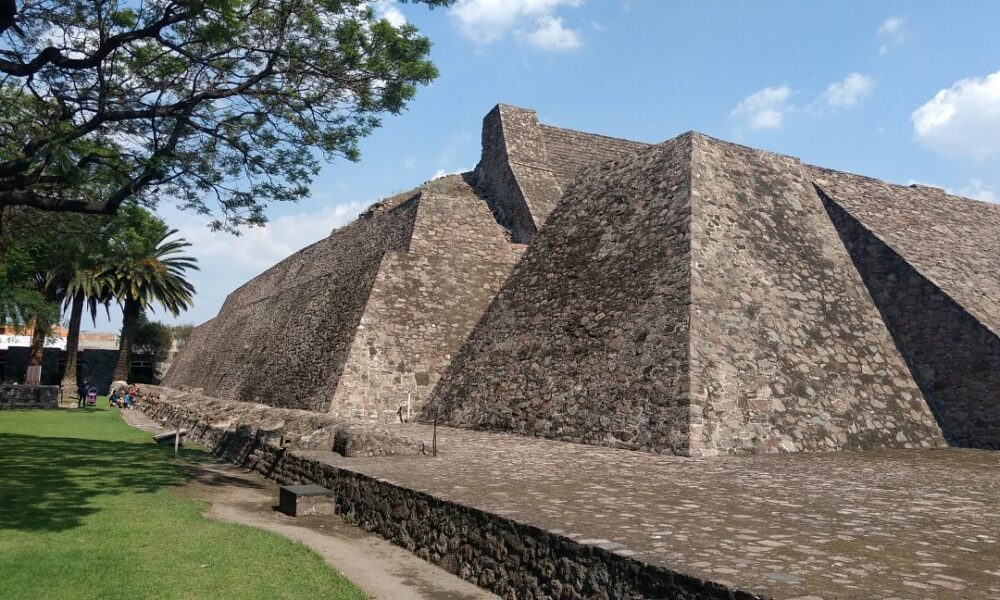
164;105;644;420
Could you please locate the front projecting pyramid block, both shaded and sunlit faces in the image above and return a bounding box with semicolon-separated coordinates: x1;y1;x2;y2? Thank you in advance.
434;134;956;455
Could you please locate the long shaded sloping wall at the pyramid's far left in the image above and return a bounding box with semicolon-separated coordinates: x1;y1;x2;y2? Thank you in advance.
164;197;417;411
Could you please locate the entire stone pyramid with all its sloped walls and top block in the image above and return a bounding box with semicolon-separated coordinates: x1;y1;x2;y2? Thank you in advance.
165;105;1000;455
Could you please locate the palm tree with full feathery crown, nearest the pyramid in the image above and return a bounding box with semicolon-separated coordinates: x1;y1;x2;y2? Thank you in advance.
105;220;198;380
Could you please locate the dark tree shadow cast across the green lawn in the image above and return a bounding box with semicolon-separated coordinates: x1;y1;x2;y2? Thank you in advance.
0;434;205;531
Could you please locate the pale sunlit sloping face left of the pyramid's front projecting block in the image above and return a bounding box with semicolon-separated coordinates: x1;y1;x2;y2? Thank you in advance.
330;175;525;420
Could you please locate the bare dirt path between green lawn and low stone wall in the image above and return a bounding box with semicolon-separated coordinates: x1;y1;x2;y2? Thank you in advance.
122;410;497;600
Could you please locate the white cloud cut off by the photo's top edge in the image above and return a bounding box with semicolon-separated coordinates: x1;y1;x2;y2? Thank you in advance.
450;0;583;50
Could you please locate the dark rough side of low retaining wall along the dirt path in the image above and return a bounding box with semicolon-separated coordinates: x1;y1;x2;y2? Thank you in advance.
140;394;761;600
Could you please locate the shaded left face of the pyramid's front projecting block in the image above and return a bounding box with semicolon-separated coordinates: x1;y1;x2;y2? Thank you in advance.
423;137;690;451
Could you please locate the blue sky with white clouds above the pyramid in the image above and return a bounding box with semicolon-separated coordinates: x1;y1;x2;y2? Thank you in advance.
87;0;1000;330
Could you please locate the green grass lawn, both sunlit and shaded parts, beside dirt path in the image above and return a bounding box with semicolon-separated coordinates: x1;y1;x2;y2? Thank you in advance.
0;406;363;599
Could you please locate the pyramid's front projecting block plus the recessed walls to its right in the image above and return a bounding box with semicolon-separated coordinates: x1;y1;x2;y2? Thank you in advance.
432;133;1000;455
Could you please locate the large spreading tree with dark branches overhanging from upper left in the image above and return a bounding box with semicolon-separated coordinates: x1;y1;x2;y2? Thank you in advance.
0;0;452;229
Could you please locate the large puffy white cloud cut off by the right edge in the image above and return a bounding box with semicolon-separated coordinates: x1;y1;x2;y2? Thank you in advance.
910;71;1000;161
